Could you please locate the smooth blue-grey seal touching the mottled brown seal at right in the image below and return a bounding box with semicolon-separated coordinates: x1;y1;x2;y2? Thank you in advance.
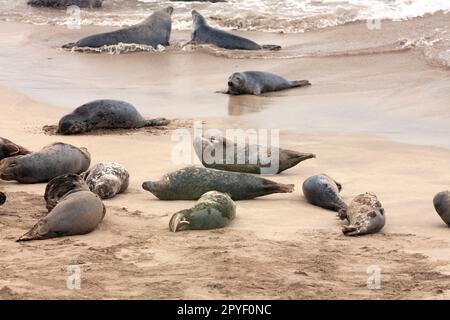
303;174;347;211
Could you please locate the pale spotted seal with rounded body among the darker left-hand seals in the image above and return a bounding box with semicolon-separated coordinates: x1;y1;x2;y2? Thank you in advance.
84;162;130;199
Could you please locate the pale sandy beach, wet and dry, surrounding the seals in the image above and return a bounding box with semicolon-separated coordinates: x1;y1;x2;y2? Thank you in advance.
0;6;450;299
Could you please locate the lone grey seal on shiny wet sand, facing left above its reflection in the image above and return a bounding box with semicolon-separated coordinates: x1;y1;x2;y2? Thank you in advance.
228;71;311;95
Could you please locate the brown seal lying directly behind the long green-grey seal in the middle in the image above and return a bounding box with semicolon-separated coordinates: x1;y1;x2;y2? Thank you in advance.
194;136;316;174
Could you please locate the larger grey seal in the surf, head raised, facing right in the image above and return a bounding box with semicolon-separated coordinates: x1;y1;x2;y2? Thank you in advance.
63;7;173;49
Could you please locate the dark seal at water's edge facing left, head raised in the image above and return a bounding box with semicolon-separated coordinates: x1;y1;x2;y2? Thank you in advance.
189;10;281;50
